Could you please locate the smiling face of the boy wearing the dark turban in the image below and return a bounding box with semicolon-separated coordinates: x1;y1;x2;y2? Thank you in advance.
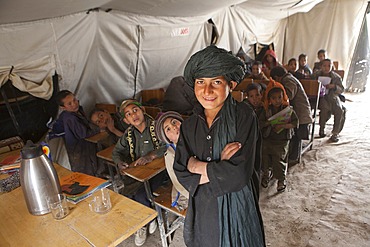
194;76;236;114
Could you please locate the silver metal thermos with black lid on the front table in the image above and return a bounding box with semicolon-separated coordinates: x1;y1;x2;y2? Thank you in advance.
19;140;61;215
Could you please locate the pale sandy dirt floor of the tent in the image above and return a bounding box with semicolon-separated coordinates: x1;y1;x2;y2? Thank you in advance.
120;89;370;247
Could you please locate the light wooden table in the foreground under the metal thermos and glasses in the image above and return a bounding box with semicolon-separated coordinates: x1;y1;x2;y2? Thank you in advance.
0;165;157;247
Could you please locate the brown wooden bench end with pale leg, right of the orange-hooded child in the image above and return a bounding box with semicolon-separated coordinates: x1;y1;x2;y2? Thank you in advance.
299;79;321;156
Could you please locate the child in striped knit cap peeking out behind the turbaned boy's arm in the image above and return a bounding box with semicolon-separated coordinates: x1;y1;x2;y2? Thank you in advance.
155;111;189;211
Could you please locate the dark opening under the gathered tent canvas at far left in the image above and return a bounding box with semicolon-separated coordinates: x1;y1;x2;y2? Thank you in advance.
0;74;59;142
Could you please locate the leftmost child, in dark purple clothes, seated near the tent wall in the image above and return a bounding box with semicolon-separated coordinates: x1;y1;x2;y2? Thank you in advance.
52;90;105;176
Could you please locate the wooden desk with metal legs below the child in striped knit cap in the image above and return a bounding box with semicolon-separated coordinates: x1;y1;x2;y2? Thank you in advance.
154;183;186;247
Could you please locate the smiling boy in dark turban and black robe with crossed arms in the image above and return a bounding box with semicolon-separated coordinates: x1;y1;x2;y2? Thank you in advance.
174;46;264;247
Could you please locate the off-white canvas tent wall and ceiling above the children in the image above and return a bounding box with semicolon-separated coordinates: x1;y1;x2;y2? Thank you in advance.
0;0;367;109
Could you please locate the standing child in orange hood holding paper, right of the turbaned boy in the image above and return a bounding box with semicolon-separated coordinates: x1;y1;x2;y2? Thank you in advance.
259;79;299;192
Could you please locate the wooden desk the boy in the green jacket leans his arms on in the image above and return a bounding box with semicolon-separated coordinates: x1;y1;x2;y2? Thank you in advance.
97;145;166;207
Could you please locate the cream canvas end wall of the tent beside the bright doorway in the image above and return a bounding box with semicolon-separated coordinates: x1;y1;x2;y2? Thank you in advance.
284;0;367;76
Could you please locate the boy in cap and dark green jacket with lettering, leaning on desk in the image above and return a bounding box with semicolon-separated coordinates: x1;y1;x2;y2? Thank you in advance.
112;99;168;246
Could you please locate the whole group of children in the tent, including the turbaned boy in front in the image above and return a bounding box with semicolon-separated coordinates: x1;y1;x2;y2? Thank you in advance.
46;46;346;246
